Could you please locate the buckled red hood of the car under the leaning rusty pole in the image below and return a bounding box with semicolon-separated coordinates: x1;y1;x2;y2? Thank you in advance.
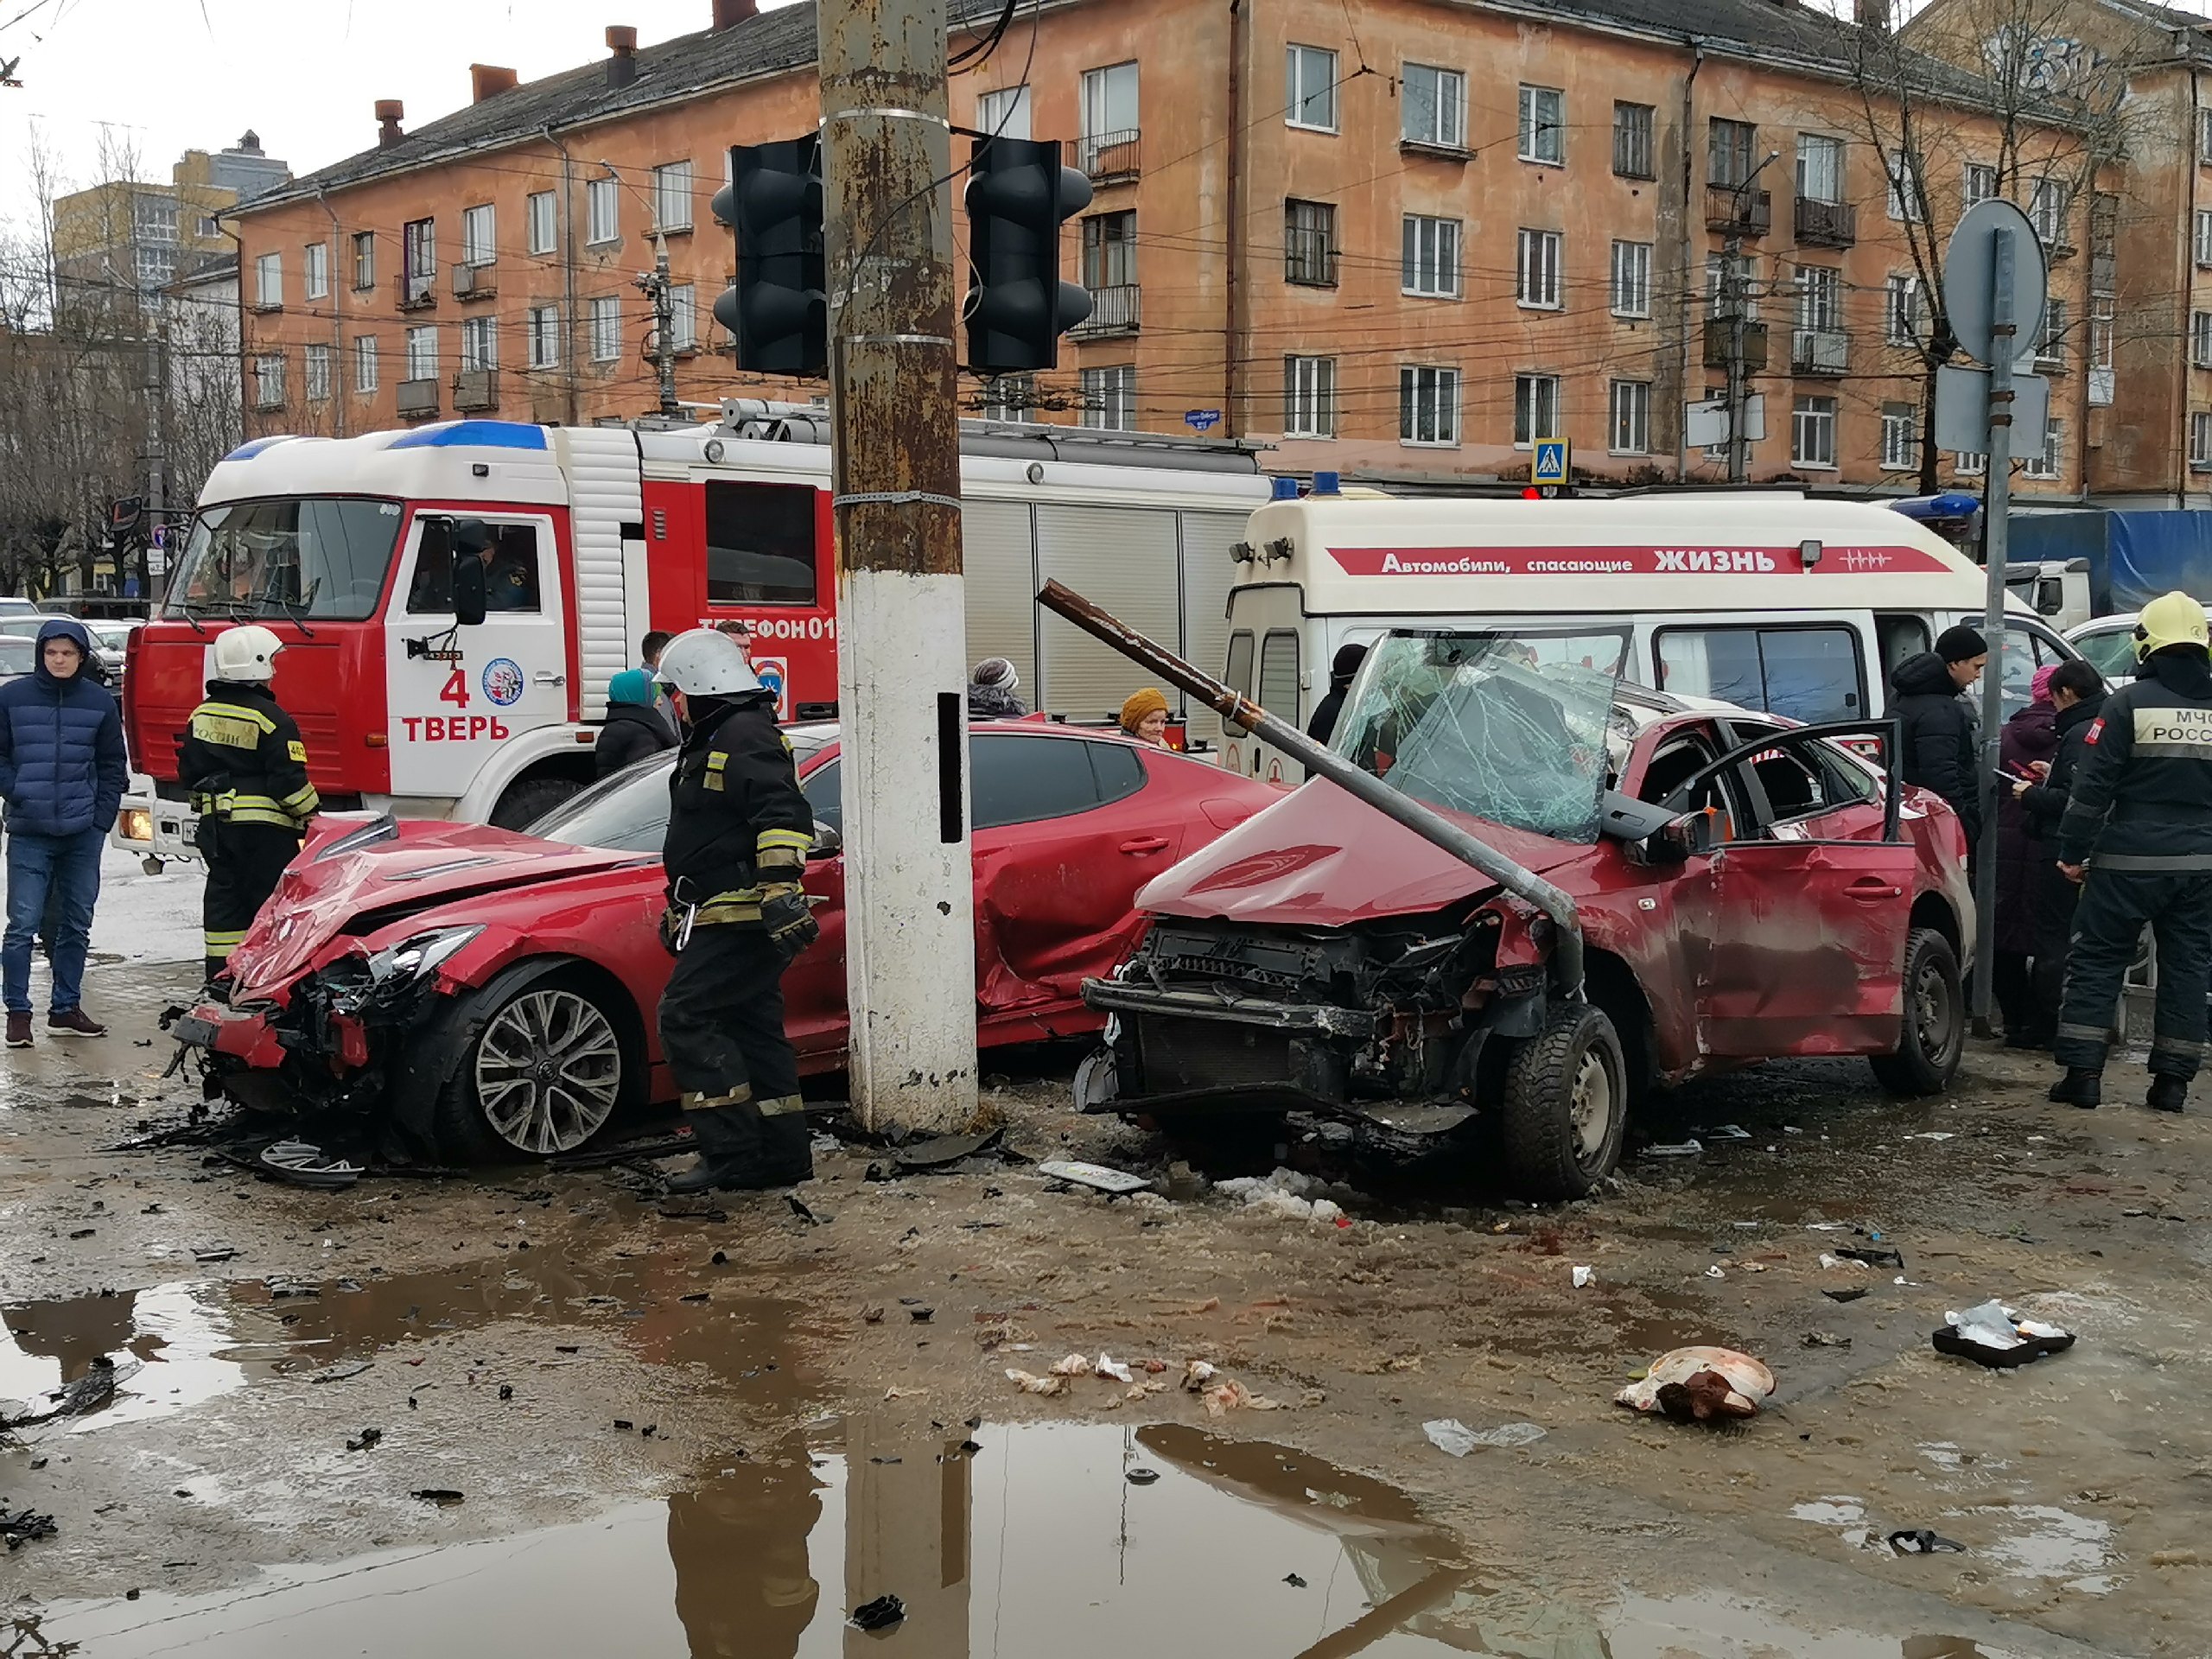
1137;779;1591;927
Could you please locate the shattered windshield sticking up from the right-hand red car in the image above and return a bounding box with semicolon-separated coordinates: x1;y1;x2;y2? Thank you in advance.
1334;624;1628;841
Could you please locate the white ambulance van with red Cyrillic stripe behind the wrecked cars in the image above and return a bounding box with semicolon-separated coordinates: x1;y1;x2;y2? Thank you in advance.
1205;491;2077;779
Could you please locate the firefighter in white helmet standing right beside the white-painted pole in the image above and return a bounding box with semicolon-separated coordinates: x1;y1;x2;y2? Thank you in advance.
659;628;821;1192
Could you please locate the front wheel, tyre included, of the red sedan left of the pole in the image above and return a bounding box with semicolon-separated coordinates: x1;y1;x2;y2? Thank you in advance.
438;978;631;1164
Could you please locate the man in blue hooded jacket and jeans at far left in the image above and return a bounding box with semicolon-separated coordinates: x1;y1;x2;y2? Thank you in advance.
0;617;124;1048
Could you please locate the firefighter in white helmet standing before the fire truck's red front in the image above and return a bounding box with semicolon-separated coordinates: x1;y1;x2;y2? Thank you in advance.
177;624;323;982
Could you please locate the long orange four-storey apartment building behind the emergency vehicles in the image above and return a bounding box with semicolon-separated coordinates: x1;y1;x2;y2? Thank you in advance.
228;0;2123;498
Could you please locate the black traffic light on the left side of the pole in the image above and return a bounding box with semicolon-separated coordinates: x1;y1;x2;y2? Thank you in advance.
715;133;830;376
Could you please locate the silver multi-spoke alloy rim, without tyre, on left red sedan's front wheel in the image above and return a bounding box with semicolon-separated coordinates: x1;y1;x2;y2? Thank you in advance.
475;991;621;1157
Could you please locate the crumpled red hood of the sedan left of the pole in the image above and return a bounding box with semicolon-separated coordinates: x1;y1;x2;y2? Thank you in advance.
230;821;657;991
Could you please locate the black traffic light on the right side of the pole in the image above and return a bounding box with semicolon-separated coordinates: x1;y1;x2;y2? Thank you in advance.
960;137;1090;374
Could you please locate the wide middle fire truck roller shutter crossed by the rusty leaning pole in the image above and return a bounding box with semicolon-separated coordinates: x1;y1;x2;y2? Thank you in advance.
1038;506;1184;721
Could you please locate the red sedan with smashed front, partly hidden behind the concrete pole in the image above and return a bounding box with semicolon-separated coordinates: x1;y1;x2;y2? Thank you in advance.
170;721;1281;1159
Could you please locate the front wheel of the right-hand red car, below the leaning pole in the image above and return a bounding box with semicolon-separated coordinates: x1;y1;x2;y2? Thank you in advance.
1500;1002;1628;1201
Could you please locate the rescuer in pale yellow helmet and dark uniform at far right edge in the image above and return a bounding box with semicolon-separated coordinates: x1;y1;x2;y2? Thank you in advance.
2050;593;2212;1113
